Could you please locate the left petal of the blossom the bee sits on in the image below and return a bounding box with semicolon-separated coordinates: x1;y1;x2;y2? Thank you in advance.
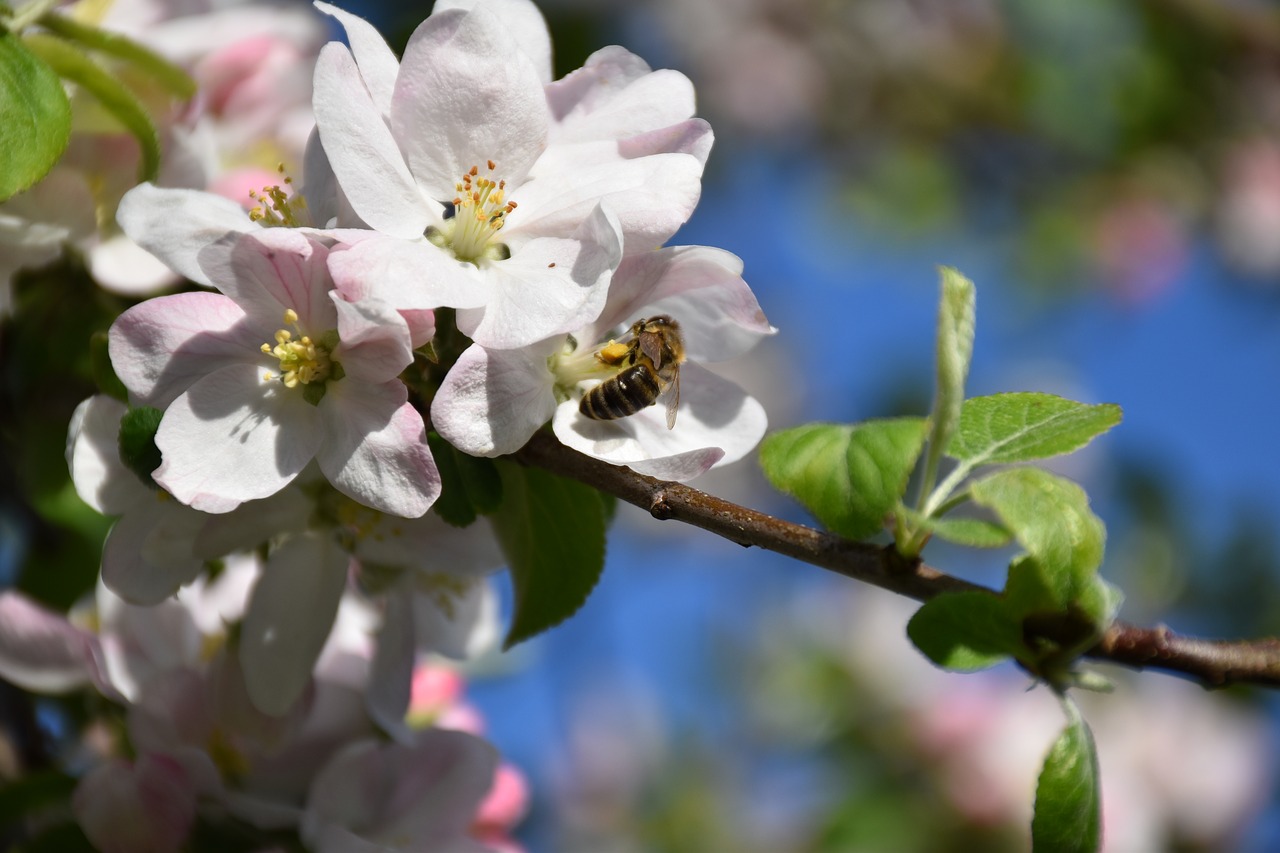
431;342;556;456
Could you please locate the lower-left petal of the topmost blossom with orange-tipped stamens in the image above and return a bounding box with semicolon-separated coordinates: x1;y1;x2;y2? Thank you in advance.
329;237;493;311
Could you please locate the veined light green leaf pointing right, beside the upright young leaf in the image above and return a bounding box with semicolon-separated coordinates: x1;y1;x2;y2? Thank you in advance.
947;393;1123;467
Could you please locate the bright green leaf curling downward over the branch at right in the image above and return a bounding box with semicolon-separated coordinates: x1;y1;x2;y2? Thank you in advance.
969;467;1106;611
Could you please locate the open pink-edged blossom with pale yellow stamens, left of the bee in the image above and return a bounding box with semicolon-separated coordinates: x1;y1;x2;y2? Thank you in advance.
110;228;440;516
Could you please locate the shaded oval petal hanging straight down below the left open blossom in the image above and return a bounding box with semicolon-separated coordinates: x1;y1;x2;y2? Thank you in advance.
239;534;349;716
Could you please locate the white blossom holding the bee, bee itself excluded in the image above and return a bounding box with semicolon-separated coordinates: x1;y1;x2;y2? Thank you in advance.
431;246;773;480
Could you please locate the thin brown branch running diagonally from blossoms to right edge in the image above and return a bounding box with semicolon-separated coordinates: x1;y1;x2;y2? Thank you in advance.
516;432;1280;688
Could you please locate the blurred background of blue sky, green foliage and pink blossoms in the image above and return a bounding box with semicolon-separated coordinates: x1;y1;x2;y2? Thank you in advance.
0;0;1280;853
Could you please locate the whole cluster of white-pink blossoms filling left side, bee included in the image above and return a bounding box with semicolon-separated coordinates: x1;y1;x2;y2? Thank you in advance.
0;0;773;850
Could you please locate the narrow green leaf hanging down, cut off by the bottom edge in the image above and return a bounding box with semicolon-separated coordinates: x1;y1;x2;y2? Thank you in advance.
1032;702;1102;853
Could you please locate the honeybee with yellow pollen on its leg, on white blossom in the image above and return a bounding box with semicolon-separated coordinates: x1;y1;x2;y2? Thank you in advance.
577;315;685;429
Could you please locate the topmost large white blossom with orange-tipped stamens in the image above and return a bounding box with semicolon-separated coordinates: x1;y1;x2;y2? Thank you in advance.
315;3;707;348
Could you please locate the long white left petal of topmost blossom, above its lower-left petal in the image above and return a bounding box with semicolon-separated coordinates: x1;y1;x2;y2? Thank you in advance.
312;44;435;240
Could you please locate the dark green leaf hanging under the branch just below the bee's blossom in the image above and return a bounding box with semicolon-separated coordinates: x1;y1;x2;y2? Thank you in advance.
490;461;604;648
